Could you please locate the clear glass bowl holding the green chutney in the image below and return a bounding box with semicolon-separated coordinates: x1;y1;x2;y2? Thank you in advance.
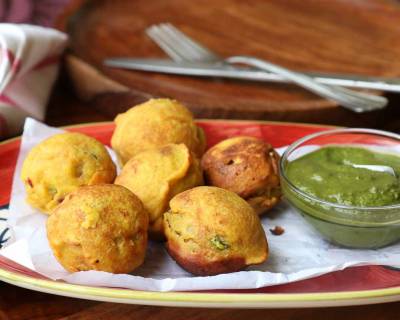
280;129;400;249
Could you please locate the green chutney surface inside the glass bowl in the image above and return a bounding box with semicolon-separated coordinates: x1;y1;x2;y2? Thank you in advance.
285;145;400;207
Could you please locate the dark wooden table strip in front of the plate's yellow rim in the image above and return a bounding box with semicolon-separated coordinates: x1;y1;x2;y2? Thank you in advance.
0;283;400;320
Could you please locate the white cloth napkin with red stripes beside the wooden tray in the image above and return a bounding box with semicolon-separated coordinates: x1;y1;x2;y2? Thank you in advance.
0;23;67;139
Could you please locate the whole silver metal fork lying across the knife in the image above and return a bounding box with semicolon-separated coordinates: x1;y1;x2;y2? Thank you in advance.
146;23;388;113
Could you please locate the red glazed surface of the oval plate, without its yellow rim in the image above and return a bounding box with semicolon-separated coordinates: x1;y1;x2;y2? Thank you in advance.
0;120;400;305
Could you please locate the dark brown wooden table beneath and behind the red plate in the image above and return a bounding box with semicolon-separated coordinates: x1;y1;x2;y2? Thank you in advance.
0;71;400;320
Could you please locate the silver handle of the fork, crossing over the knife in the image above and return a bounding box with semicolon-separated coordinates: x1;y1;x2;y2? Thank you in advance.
225;56;388;113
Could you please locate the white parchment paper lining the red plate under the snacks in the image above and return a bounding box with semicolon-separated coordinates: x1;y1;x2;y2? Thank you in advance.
0;119;400;291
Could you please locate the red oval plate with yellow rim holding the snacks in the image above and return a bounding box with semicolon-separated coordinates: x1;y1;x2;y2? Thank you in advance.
0;120;400;308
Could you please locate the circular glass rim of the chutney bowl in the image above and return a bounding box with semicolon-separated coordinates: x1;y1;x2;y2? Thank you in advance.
279;128;400;211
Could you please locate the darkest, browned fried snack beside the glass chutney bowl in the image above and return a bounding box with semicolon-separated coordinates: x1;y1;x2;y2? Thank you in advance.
201;136;282;214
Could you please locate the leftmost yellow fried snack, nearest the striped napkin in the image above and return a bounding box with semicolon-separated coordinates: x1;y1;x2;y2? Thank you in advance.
21;132;116;214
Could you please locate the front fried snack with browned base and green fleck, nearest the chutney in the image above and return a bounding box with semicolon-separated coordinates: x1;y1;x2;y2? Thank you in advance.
164;186;268;276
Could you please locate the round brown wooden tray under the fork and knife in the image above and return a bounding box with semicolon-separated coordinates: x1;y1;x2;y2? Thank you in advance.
57;0;400;126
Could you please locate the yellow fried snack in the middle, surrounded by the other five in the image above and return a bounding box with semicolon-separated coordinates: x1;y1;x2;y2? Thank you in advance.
115;144;203;240
